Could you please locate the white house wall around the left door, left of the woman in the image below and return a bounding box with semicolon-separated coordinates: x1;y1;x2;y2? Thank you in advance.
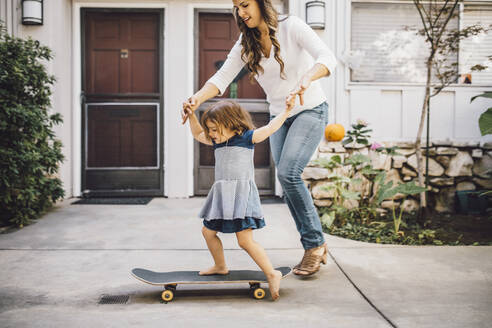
4;0;283;197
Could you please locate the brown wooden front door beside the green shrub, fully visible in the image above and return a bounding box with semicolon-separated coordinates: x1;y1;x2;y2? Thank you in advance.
83;10;163;195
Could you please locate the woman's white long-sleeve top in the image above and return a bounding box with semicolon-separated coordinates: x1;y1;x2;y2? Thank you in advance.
207;16;337;116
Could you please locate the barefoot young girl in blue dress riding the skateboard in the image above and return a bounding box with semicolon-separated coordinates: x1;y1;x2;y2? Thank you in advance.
183;97;295;300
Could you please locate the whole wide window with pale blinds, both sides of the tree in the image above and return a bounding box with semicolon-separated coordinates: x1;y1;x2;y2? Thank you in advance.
346;1;492;84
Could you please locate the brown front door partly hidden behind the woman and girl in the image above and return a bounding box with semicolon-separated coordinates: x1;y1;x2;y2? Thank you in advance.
194;13;275;195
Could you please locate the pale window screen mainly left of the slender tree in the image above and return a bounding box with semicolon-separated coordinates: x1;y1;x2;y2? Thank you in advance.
350;3;458;83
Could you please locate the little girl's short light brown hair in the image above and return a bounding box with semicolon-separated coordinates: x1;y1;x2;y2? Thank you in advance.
201;100;255;139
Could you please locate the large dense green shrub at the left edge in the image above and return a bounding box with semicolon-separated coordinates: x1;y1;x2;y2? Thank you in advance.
0;25;64;227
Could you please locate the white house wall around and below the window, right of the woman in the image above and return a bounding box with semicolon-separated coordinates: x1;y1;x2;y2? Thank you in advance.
289;0;492;141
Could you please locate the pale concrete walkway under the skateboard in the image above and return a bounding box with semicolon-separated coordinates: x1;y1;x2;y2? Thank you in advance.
0;198;492;328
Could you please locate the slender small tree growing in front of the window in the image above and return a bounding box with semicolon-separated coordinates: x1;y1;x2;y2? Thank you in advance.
413;0;487;214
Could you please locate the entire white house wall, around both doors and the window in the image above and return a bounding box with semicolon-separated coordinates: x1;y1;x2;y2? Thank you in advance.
5;0;492;197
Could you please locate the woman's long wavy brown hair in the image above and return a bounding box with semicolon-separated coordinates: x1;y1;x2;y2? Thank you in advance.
232;0;286;81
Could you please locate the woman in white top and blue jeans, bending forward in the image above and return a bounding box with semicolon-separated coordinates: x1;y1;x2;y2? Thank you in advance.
182;0;336;276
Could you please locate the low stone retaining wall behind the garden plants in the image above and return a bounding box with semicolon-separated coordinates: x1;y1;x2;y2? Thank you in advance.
302;140;492;212
